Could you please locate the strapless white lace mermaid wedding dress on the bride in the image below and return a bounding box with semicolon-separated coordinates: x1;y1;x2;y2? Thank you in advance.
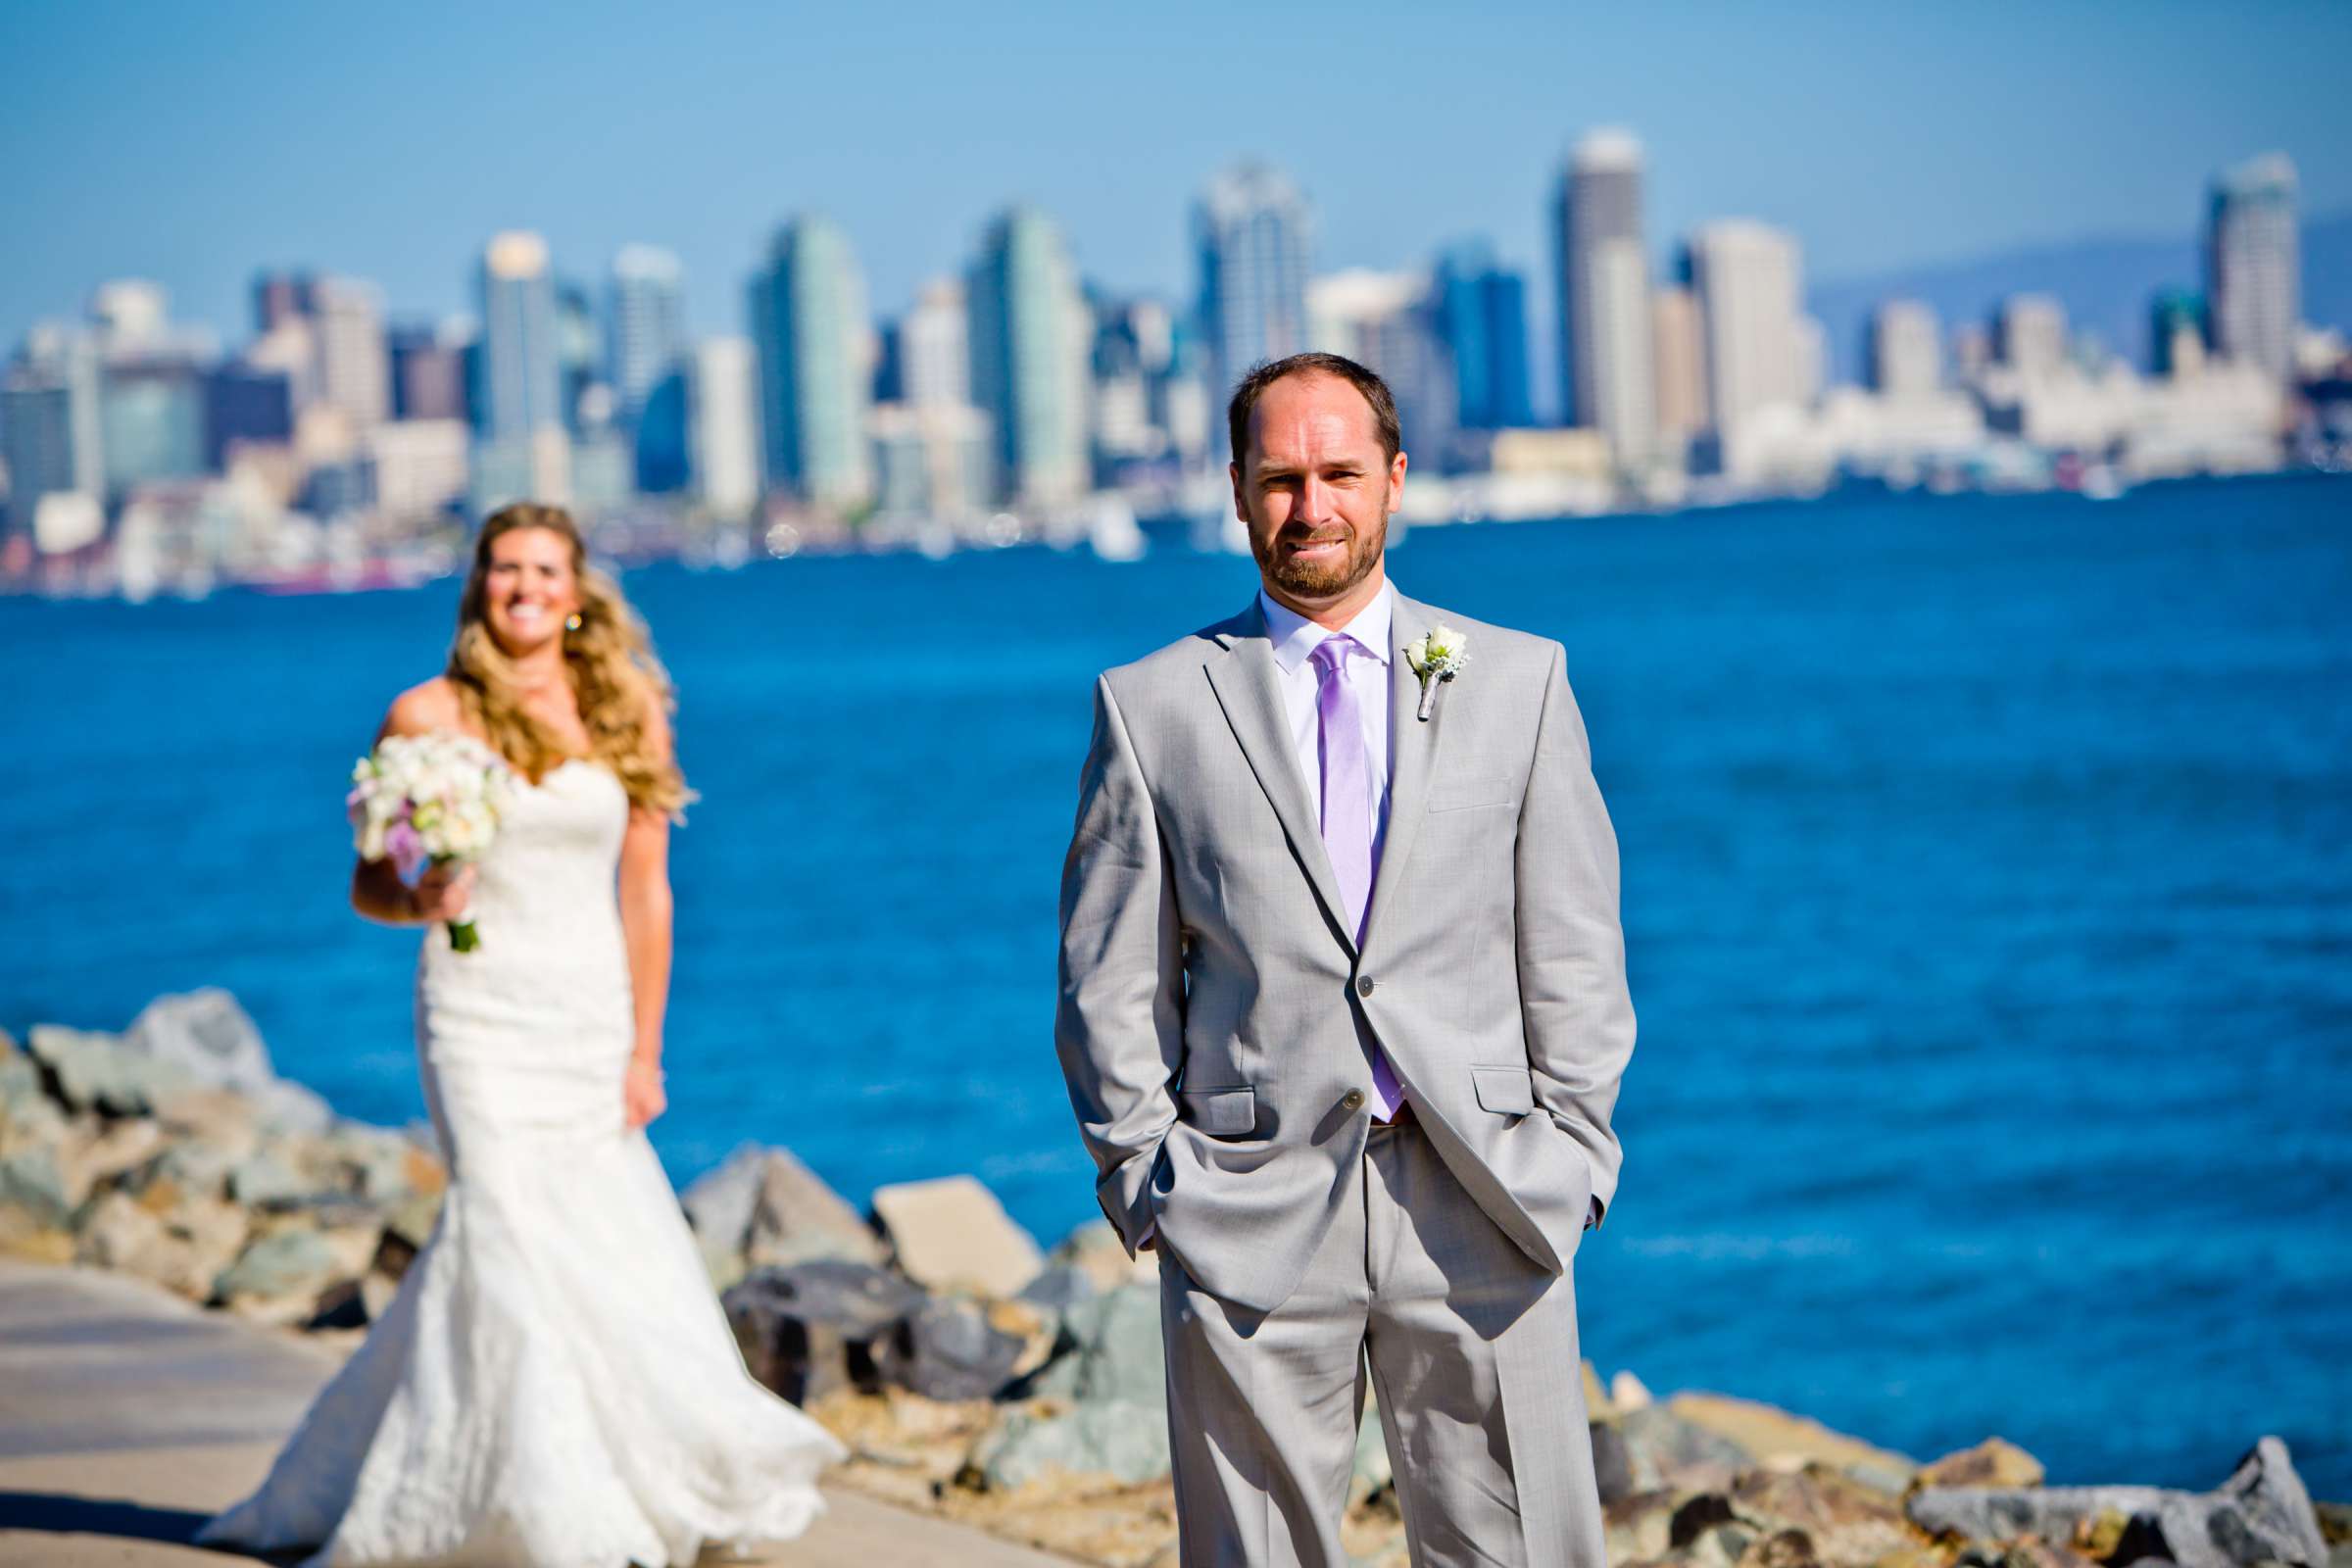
198;761;842;1568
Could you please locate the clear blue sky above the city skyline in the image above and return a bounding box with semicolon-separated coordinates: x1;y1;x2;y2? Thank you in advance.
0;0;2352;357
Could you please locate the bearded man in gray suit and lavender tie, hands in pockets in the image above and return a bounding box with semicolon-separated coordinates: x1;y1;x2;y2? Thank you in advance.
1056;355;1635;1568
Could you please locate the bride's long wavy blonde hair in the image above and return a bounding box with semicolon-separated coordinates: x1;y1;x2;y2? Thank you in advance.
447;501;694;820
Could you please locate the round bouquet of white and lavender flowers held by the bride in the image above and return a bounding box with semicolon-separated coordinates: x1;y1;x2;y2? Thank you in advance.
343;733;513;953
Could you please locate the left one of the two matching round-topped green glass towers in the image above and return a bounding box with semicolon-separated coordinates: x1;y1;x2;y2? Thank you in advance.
751;214;872;506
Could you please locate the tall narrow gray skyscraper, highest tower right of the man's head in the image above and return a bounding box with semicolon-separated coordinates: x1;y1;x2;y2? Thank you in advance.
1552;129;1658;466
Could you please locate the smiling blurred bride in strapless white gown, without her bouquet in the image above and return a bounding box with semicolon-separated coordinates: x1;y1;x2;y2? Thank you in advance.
200;506;842;1568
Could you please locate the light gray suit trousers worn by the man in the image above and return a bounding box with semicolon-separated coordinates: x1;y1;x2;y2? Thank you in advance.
1159;1121;1606;1568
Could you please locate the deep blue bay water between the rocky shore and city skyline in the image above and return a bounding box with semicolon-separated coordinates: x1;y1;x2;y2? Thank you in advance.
0;479;2352;1497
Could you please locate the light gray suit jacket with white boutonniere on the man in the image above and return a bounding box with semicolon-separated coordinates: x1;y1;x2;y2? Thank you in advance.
1054;595;1635;1312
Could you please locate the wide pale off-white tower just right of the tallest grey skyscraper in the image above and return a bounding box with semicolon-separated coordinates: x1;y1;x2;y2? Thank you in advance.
1691;219;1809;467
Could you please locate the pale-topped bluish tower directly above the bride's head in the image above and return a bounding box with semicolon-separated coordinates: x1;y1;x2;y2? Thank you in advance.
468;230;571;508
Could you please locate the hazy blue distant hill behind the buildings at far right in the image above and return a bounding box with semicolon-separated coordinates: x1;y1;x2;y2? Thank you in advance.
1809;212;2352;381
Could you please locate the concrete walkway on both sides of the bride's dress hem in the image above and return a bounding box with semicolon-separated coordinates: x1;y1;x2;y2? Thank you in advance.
0;1260;1068;1568
